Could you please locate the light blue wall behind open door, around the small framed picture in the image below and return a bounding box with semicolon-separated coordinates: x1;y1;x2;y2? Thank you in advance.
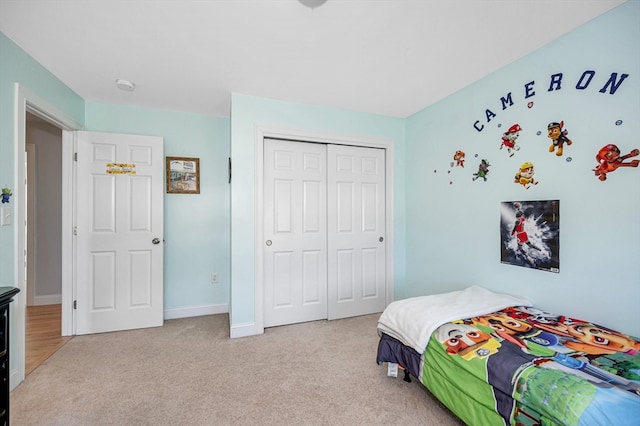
86;102;230;310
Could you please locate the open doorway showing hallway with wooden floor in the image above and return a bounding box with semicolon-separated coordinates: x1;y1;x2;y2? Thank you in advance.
24;111;71;376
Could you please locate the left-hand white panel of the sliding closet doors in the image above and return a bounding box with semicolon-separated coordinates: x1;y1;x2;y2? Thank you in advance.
264;139;327;327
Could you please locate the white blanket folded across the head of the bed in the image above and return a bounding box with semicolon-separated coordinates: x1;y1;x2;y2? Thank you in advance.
378;286;531;354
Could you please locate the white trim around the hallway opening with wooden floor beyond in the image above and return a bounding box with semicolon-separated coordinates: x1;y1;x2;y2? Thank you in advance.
9;83;82;390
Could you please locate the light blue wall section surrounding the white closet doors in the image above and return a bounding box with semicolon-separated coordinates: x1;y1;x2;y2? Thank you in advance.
231;94;405;327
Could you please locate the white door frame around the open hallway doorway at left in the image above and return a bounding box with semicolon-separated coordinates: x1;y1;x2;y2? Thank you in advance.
9;83;82;390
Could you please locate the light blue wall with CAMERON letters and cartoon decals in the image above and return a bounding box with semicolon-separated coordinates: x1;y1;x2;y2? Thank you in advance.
403;1;640;335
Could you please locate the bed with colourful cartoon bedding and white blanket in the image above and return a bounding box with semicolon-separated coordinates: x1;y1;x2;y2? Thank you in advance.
377;286;640;426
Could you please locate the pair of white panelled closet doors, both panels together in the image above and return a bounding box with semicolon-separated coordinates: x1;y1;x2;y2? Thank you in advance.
263;139;386;327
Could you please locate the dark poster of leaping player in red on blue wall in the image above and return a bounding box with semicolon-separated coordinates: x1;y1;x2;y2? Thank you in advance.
500;200;560;272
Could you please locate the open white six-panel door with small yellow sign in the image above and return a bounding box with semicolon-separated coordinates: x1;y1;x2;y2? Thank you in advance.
75;132;164;334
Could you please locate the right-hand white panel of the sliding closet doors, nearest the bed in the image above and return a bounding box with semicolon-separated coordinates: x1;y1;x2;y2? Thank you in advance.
327;145;386;319
